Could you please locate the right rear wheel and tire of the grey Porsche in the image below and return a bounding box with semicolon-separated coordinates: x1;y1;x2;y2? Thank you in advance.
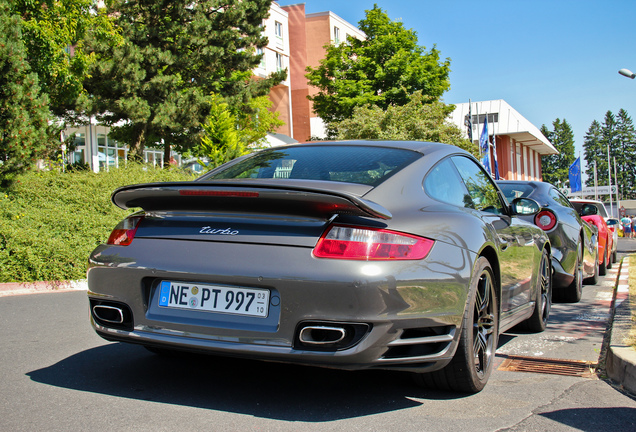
415;257;499;393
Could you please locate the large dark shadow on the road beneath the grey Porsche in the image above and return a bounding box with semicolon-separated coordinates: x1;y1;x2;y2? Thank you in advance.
27;343;466;422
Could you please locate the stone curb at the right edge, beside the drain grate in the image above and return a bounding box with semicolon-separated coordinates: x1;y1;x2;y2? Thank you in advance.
605;257;636;394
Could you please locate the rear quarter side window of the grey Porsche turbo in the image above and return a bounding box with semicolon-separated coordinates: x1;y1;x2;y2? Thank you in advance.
424;159;474;208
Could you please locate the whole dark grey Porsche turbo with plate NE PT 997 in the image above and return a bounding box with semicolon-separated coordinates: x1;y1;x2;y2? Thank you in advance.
88;141;552;392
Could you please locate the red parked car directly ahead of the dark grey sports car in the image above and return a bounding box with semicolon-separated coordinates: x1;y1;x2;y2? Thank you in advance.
570;199;616;276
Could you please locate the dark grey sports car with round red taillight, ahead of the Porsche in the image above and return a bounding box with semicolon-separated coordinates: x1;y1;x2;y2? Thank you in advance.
497;180;599;302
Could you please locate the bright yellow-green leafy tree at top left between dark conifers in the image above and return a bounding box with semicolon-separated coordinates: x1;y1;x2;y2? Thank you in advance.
10;0;116;118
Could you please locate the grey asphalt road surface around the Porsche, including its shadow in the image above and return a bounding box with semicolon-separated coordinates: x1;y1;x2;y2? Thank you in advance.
0;266;636;432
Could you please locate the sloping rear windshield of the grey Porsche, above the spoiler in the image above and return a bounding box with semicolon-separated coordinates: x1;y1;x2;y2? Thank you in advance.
201;145;422;186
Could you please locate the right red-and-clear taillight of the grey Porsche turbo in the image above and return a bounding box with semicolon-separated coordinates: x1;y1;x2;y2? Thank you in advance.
314;226;434;261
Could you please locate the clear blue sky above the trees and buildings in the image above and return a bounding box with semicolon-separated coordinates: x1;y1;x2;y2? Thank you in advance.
278;0;636;160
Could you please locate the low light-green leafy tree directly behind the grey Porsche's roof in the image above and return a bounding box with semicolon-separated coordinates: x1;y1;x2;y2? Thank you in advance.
332;91;479;155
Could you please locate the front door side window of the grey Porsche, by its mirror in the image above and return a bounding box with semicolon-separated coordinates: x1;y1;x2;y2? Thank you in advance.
452;156;504;214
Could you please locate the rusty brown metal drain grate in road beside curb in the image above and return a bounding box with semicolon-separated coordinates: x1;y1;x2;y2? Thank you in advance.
497;356;597;378
